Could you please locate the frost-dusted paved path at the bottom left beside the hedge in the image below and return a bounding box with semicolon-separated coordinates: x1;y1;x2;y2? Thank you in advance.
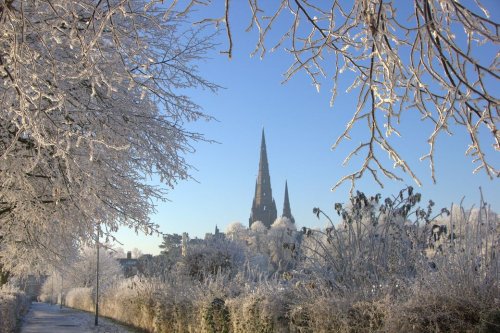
21;302;135;333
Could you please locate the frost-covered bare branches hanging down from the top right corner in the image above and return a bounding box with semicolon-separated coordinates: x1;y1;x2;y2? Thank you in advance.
170;0;500;191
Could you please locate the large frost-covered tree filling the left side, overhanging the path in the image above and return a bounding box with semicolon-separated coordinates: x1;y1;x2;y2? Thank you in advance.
0;0;217;268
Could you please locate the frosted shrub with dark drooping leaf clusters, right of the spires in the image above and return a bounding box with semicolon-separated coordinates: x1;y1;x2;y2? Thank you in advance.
301;187;440;291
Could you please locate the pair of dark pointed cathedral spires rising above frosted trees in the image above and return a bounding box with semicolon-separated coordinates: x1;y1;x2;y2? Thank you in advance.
248;129;295;228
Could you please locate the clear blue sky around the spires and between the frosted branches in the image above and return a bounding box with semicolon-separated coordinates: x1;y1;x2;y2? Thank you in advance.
112;1;500;254
